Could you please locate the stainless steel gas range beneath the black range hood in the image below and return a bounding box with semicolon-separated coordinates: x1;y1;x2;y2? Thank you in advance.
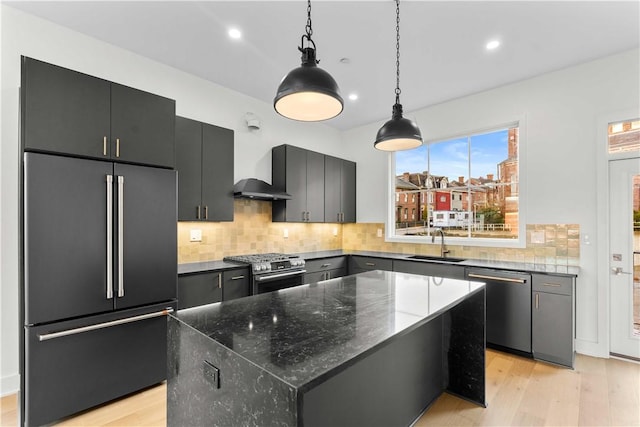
224;253;306;295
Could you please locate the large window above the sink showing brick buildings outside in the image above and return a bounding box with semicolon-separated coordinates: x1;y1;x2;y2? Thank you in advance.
390;124;520;244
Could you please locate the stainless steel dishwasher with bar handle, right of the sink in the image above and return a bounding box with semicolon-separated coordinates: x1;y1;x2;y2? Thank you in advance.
466;267;531;356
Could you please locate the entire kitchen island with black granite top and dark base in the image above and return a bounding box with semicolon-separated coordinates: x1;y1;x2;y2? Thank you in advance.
167;270;485;426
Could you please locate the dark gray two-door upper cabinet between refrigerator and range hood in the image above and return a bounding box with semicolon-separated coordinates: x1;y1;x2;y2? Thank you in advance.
176;117;234;221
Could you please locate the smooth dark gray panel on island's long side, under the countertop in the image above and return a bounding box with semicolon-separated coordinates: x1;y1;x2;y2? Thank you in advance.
301;317;445;427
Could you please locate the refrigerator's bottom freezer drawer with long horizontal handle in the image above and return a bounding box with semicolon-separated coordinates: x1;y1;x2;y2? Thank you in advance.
22;304;167;426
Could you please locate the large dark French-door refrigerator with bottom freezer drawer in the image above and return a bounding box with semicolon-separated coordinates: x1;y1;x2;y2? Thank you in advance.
20;152;177;425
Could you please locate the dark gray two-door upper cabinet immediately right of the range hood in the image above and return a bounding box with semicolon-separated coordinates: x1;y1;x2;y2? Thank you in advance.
272;145;325;222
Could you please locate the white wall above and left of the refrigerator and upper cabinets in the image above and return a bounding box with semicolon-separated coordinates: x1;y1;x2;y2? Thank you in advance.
0;5;344;395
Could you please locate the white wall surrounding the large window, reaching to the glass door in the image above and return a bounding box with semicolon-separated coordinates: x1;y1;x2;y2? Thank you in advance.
343;50;640;356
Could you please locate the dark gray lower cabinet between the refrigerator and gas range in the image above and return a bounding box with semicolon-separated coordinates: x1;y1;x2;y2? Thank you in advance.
178;268;249;309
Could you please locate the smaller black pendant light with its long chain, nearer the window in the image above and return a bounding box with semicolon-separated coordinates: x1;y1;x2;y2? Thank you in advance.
373;0;422;151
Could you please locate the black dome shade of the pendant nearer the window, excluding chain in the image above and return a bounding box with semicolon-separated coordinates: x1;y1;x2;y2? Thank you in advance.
373;104;422;151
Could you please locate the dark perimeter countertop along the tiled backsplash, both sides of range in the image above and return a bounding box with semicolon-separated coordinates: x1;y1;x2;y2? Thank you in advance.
178;249;580;277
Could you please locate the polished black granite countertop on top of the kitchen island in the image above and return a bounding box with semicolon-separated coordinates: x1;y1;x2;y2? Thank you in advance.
173;270;484;388
